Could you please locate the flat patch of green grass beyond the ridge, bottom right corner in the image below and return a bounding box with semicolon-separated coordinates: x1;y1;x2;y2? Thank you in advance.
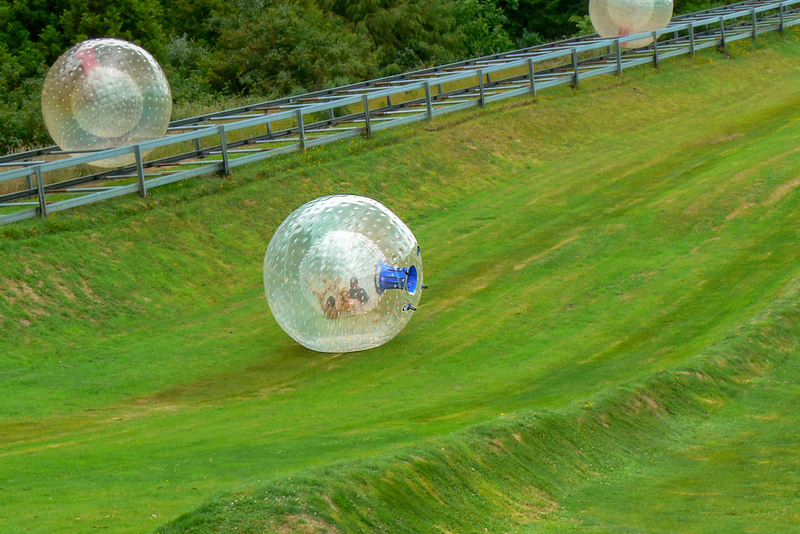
520;355;800;534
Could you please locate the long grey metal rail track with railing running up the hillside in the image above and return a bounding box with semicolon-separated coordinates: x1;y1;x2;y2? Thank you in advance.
0;0;800;224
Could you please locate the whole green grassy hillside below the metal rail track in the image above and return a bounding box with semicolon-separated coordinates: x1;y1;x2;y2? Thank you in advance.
0;32;800;532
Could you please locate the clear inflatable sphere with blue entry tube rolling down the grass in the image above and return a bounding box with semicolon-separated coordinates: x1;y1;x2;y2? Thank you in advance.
264;195;422;352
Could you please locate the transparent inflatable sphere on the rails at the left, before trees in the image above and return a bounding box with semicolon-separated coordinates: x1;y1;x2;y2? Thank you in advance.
42;39;172;167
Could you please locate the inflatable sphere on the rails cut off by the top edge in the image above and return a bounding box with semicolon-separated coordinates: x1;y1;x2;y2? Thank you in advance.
589;0;672;48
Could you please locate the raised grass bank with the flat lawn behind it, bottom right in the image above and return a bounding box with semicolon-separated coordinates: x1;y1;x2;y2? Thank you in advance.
166;281;800;534
